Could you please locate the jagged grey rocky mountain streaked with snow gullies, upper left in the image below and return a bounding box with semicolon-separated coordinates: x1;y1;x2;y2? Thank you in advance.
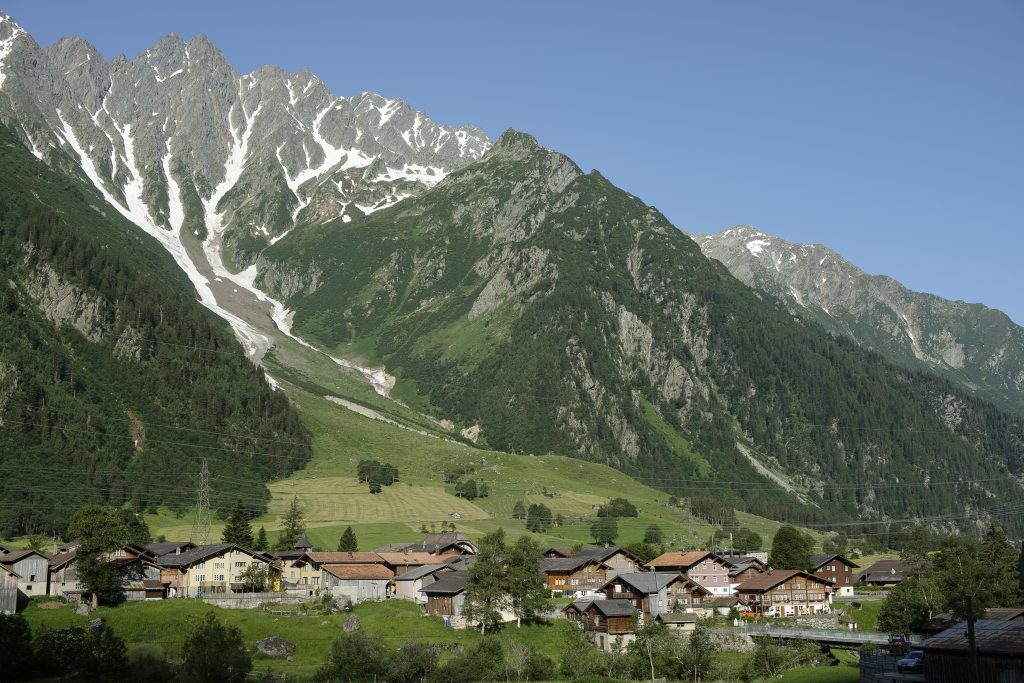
0;14;489;360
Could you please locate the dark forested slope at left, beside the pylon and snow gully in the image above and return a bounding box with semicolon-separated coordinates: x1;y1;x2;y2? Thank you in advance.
0;127;310;535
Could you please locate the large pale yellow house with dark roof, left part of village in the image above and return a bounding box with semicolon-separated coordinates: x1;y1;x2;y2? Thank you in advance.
157;543;281;598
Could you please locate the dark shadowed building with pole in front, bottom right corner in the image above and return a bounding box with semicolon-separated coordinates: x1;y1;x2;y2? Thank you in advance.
923;620;1024;683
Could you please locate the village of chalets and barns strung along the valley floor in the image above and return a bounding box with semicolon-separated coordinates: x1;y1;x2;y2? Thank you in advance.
0;531;1024;680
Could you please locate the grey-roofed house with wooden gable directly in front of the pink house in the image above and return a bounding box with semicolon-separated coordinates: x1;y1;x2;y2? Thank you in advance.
601;571;713;624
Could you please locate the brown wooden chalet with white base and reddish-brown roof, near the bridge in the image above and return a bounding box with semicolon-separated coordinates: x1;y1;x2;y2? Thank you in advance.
736;569;833;616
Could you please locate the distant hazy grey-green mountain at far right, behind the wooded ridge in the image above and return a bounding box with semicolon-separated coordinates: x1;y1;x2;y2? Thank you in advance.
694;226;1024;415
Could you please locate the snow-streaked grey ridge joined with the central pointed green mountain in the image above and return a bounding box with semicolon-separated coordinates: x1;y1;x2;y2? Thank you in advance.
0;12;1024;540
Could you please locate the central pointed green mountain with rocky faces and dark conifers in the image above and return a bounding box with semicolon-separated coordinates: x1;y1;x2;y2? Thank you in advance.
257;127;1024;532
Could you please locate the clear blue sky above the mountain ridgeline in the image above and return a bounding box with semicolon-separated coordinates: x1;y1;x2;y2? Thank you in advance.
8;0;1024;324
